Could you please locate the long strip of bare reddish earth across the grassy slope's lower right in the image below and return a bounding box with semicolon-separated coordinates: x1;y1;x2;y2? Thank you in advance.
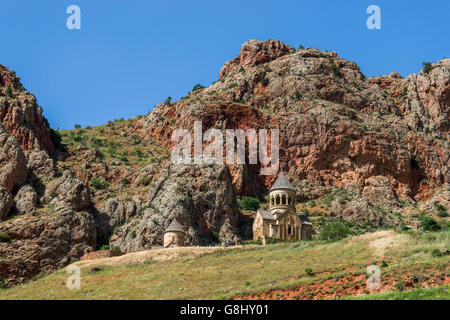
234;269;450;300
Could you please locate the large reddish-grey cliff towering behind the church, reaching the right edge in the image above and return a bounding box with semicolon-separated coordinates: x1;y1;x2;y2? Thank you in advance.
135;40;450;207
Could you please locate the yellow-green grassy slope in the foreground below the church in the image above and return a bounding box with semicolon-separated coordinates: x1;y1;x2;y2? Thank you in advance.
0;231;450;299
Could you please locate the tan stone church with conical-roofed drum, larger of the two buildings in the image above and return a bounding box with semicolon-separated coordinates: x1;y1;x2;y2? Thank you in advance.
253;173;312;244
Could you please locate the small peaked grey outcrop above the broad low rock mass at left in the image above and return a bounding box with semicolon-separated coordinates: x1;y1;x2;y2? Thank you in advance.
43;170;91;211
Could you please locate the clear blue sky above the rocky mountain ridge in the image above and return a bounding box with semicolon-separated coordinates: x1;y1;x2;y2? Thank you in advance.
0;0;450;129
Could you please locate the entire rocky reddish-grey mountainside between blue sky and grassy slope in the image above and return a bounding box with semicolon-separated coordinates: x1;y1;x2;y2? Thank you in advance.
0;40;450;284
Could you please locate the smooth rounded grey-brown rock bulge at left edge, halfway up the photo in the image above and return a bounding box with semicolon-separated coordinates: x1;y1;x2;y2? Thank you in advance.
0;126;27;192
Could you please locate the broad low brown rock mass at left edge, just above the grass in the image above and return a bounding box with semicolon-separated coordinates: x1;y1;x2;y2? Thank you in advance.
0;210;96;285
